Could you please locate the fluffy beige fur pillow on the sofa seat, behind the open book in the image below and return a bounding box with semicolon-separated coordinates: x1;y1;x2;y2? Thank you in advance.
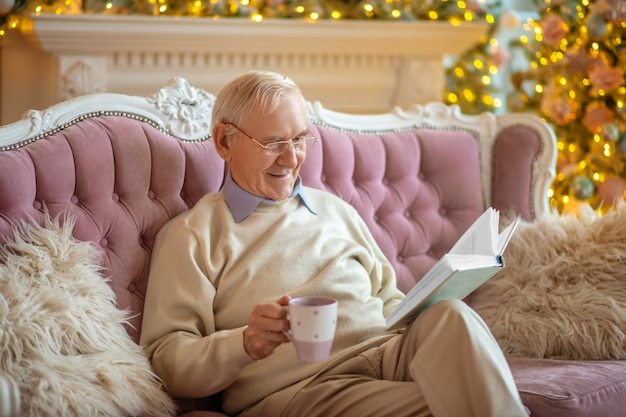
468;202;626;359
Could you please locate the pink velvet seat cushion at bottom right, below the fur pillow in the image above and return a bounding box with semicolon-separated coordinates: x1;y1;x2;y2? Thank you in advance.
507;357;626;417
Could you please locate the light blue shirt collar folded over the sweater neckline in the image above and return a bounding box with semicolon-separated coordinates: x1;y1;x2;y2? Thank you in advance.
223;172;316;223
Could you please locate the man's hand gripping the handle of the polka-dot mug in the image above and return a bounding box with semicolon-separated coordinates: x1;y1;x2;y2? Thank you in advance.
243;295;291;361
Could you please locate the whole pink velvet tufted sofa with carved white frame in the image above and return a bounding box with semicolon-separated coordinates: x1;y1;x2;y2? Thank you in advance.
0;78;626;417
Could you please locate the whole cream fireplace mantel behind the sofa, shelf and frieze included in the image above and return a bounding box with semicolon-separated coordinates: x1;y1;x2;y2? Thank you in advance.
0;14;486;124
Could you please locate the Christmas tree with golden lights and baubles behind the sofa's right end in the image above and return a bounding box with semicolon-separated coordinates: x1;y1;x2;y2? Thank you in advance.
507;0;626;213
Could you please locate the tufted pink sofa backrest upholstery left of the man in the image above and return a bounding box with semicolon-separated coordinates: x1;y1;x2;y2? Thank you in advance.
0;116;224;341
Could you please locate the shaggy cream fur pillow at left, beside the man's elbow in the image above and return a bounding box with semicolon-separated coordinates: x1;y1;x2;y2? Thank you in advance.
0;219;175;417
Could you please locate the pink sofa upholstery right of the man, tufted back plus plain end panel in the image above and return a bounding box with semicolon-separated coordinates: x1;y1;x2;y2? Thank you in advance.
301;123;545;292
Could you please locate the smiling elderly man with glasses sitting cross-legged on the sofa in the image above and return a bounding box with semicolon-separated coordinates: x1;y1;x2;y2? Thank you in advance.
141;71;526;417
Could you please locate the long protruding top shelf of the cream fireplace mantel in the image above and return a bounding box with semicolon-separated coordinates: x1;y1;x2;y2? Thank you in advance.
19;15;486;56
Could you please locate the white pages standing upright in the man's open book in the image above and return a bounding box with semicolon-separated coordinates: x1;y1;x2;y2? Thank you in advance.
448;207;500;256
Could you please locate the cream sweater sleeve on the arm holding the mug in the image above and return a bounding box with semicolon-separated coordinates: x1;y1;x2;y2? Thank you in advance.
140;221;253;398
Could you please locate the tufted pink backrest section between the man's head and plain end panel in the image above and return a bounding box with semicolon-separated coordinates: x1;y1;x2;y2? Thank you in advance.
301;125;484;292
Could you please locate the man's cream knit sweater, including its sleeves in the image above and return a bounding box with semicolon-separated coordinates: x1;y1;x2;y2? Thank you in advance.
141;187;403;414
